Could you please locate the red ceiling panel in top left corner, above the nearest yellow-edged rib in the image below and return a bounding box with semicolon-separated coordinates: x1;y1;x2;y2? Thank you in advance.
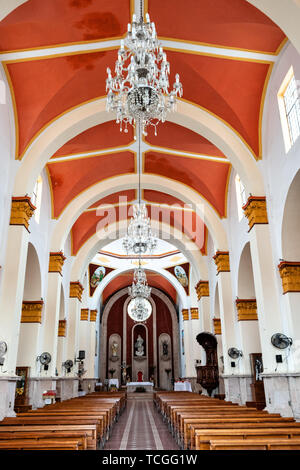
0;0;130;51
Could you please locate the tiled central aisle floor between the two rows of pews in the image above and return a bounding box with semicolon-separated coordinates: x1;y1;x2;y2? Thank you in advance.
104;393;179;450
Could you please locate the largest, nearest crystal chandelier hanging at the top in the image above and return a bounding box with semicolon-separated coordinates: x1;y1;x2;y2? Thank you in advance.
106;1;182;135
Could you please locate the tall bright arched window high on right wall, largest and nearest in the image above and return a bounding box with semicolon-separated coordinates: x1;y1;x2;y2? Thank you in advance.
278;67;300;152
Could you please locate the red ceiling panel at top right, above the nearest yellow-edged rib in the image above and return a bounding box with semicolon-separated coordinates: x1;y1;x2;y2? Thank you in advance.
147;0;285;52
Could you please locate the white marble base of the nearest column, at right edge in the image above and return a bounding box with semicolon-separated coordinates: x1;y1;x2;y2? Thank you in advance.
262;373;300;421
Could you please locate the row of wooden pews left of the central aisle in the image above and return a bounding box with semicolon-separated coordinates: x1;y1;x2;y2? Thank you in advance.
0;392;126;450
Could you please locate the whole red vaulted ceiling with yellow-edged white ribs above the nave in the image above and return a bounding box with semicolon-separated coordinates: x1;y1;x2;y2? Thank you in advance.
0;0;286;300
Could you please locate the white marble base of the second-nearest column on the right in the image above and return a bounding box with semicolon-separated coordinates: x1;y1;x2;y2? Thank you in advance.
221;374;252;405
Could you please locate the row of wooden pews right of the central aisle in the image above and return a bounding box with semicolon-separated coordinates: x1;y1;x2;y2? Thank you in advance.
153;391;300;450
